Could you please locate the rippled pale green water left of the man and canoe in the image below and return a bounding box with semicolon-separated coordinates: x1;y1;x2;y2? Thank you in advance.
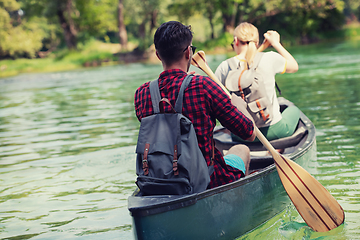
0;64;161;239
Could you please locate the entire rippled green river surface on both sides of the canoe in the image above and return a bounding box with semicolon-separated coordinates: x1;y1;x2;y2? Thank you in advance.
0;41;360;239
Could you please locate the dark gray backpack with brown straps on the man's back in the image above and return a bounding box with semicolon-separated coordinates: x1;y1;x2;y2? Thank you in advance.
136;75;213;195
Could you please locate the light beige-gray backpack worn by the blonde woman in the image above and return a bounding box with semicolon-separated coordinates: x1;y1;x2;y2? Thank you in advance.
225;53;280;127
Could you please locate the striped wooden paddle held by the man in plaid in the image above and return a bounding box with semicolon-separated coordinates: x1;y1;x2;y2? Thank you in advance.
191;51;345;232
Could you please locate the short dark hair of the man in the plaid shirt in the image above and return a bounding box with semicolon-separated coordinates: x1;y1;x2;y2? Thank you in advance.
154;21;193;64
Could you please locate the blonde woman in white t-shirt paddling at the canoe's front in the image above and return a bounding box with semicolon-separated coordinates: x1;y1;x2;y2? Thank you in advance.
215;22;300;141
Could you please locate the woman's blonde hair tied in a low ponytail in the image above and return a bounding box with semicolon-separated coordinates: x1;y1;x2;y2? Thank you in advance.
234;22;259;67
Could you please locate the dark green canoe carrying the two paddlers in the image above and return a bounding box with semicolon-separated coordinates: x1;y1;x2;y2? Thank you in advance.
128;98;316;240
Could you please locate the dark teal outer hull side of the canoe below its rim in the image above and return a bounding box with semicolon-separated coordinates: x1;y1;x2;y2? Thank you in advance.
133;144;316;240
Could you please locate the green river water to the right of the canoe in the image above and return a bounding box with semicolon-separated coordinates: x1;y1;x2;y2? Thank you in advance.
239;41;360;239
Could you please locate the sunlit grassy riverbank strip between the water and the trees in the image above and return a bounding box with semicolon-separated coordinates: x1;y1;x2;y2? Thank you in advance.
0;23;360;79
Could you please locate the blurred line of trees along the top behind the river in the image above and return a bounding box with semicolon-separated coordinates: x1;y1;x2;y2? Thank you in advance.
0;0;360;58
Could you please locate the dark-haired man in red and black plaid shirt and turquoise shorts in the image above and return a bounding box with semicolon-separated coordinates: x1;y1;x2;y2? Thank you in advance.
135;21;255;188
